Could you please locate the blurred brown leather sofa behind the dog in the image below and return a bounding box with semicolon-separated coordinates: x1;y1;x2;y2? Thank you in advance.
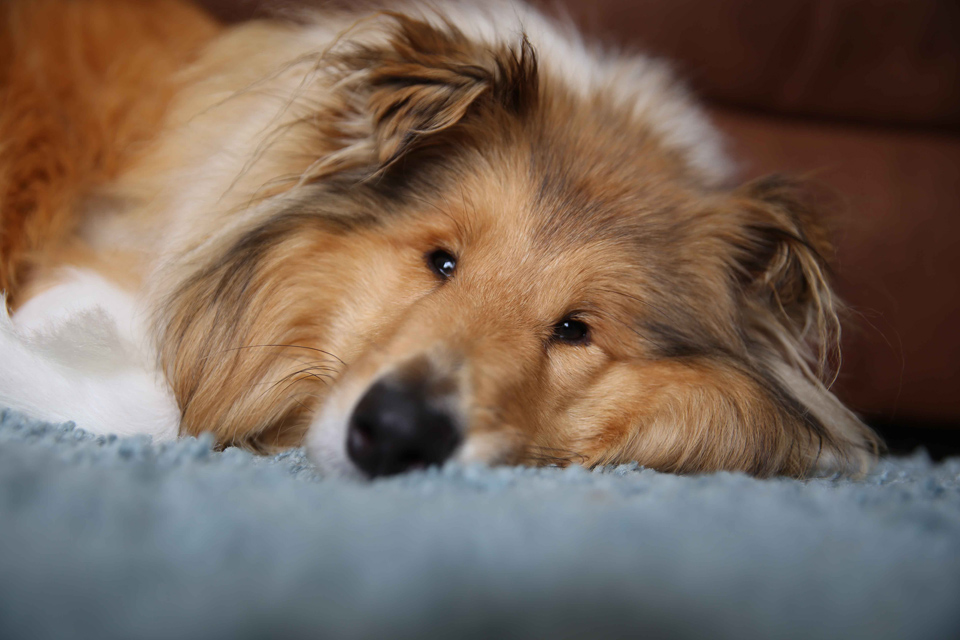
200;0;960;457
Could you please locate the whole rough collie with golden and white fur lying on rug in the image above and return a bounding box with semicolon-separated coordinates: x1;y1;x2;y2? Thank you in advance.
0;0;878;476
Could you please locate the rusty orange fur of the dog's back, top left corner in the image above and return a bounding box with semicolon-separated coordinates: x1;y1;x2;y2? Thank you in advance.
0;0;217;304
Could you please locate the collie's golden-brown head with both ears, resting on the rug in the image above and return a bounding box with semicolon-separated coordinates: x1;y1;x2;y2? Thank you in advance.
162;7;877;476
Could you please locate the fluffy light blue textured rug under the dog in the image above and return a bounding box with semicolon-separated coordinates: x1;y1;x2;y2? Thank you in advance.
0;412;960;640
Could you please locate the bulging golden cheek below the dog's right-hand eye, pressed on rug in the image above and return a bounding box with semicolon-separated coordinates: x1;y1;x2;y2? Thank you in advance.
568;359;848;477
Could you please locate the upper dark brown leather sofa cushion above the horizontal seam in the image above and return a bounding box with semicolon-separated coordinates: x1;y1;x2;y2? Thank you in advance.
542;0;960;128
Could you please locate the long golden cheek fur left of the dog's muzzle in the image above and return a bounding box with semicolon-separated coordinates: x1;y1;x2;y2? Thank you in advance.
162;233;412;448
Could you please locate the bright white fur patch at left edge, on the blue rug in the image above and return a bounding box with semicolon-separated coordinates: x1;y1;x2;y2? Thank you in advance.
0;270;180;439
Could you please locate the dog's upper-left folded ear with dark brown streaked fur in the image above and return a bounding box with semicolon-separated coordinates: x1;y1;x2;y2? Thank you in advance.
320;12;537;169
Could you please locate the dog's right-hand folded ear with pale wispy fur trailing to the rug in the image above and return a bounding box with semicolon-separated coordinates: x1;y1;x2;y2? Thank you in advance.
733;176;882;471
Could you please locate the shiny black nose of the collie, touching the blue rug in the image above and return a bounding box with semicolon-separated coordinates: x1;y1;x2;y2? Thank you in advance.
347;381;460;477
